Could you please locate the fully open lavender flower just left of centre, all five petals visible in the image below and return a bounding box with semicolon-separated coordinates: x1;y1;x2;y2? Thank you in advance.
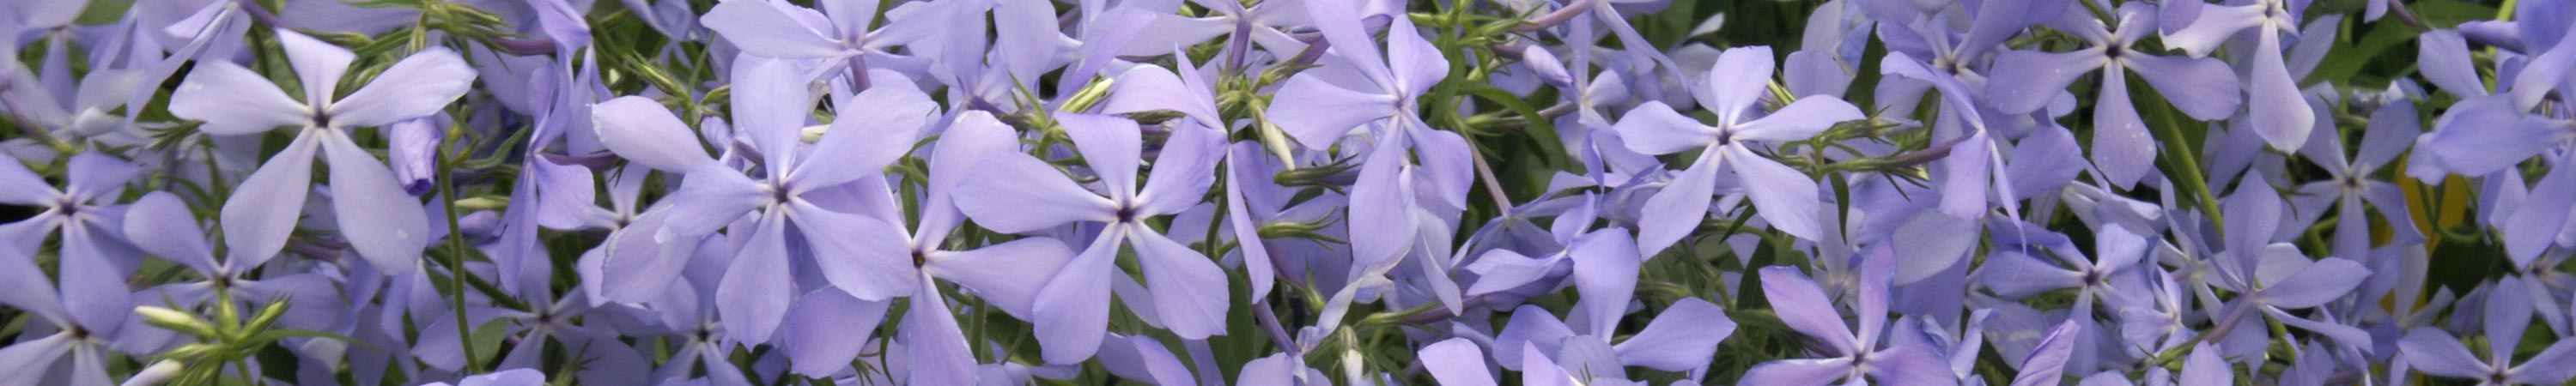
956;113;1229;363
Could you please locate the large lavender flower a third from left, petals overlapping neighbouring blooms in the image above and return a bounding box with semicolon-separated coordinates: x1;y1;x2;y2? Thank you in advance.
592;57;938;342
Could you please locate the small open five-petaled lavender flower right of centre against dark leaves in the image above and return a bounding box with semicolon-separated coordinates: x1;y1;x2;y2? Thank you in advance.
1613;46;1862;252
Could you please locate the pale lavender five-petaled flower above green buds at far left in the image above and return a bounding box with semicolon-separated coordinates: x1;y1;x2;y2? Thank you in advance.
170;28;474;273
